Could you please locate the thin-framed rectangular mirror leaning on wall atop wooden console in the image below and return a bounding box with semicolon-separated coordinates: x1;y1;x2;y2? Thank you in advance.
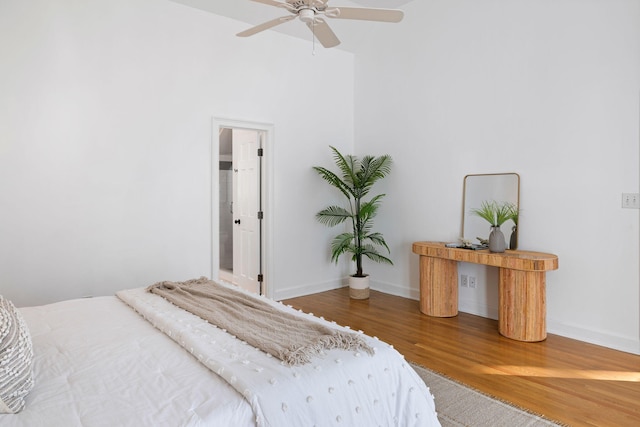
462;173;520;250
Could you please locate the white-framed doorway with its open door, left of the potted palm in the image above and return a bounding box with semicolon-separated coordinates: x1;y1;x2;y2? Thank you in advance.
212;119;271;296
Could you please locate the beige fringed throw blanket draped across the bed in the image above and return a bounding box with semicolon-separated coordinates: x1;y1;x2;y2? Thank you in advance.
147;277;373;365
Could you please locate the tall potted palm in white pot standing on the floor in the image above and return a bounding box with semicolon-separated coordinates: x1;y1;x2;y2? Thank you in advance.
313;147;393;299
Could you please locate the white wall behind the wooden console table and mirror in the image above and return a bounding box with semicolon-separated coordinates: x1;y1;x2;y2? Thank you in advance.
355;0;640;353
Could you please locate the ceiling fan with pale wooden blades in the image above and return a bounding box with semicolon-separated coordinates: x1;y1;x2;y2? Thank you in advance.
237;0;404;48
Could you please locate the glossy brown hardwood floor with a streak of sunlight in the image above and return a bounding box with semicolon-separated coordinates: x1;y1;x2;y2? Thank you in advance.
285;288;640;426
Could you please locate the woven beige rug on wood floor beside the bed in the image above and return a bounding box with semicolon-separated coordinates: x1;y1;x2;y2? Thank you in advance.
411;363;561;427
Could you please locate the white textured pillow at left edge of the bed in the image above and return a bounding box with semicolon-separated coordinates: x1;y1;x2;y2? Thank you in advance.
0;295;33;414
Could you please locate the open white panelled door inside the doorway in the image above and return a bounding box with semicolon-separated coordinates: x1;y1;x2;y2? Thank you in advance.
232;128;260;293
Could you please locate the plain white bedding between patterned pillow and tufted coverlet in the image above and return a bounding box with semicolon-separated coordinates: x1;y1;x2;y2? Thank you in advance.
0;296;255;427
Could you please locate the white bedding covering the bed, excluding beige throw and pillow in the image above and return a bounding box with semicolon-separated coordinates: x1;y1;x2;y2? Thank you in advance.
0;284;439;427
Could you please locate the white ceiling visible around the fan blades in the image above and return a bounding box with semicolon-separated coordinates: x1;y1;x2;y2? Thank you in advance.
171;0;414;53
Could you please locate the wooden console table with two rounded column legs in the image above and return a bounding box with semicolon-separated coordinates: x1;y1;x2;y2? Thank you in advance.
413;242;558;342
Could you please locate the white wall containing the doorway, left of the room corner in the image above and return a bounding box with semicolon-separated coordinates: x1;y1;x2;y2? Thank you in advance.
0;0;354;306
